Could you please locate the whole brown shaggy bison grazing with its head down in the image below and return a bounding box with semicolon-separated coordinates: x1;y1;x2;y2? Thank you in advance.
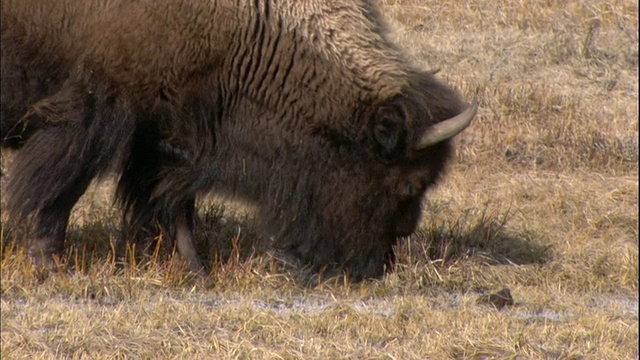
1;0;476;280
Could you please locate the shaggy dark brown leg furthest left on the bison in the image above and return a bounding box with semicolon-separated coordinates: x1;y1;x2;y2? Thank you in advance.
6;82;135;265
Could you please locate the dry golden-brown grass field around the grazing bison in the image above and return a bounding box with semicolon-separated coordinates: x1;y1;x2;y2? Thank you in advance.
0;0;639;359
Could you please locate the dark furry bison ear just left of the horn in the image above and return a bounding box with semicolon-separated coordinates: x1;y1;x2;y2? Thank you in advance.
372;102;406;157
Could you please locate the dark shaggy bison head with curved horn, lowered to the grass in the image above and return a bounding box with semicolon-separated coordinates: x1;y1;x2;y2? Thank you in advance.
255;73;477;280
